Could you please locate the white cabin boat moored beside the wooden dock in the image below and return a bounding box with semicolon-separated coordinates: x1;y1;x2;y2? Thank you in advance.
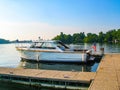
16;40;89;62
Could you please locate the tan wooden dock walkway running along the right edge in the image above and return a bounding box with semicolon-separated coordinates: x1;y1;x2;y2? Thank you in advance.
89;54;120;90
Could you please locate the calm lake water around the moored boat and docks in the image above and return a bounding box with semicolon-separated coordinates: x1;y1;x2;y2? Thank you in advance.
0;44;120;90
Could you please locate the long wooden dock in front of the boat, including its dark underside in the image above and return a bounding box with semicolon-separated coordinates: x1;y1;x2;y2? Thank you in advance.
0;68;95;89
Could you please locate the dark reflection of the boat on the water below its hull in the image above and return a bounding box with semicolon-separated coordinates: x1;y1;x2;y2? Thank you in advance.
18;60;96;72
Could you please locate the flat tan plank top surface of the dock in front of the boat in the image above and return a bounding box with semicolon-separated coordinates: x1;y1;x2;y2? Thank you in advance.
0;67;96;83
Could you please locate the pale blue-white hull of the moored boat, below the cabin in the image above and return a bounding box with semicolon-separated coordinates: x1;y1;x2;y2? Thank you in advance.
20;50;87;62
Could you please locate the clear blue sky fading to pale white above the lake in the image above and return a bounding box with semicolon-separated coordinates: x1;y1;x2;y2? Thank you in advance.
0;0;120;40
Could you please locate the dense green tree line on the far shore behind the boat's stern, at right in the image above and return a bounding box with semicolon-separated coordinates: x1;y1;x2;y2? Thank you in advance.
53;29;120;44
